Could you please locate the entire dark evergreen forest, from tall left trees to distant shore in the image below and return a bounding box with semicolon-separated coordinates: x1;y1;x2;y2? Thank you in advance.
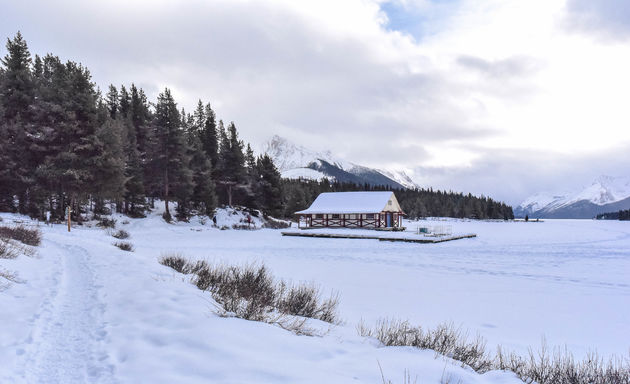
0;32;513;221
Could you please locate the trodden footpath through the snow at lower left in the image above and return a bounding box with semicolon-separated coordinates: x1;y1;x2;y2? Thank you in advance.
24;241;114;383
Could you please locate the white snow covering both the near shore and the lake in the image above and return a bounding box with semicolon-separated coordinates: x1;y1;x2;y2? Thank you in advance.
0;208;630;383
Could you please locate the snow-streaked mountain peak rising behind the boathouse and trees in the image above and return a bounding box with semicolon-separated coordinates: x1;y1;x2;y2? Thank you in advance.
263;135;418;188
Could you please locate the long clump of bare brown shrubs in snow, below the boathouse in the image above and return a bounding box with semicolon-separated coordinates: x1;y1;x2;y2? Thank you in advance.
160;254;339;328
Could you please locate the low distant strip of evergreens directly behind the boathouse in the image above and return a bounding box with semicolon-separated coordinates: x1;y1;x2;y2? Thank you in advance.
282;179;514;220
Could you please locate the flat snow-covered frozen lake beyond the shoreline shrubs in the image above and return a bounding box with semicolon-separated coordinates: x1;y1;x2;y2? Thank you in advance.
142;216;630;355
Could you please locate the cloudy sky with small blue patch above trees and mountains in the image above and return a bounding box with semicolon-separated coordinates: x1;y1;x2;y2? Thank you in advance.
0;0;630;203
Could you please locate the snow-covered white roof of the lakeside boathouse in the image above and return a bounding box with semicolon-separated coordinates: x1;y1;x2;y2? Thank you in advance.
295;191;401;215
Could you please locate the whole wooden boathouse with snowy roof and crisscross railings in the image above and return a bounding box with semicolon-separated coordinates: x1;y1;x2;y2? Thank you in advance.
295;192;404;230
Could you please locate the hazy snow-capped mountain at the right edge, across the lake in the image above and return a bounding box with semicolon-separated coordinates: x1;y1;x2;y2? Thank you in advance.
514;176;630;219
